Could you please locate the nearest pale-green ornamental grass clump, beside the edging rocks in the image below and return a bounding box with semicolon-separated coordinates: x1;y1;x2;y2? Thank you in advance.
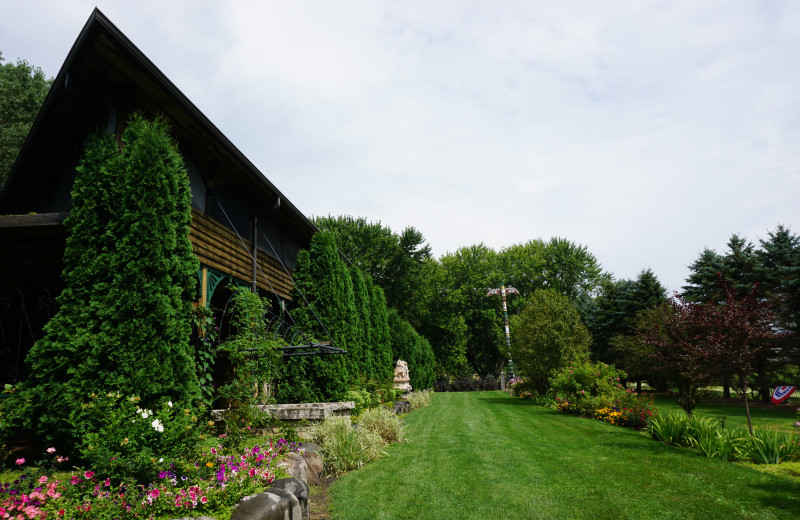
309;417;384;475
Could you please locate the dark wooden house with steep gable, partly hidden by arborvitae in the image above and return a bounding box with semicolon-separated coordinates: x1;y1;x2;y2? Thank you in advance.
0;9;316;382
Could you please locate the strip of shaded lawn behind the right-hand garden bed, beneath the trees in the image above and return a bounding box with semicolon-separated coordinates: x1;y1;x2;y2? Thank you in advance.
655;395;798;433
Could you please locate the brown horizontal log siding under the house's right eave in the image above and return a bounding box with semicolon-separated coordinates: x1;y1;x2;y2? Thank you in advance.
189;208;292;299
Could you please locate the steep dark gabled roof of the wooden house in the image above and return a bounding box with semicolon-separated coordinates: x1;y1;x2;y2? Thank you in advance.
0;9;316;246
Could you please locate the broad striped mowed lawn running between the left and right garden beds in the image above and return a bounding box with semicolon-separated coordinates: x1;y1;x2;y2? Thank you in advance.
330;392;800;520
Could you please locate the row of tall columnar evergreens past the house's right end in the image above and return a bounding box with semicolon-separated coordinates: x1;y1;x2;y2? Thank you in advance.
278;233;404;402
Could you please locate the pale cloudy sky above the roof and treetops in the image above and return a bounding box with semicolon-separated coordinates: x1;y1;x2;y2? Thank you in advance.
0;0;800;291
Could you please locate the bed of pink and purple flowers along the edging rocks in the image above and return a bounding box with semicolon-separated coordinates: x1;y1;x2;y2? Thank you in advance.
0;439;301;519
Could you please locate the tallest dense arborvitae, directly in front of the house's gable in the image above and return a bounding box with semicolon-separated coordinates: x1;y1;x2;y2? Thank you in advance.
22;115;199;443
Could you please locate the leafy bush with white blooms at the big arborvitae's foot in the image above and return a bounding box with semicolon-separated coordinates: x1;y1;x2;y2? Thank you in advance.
70;393;205;482
